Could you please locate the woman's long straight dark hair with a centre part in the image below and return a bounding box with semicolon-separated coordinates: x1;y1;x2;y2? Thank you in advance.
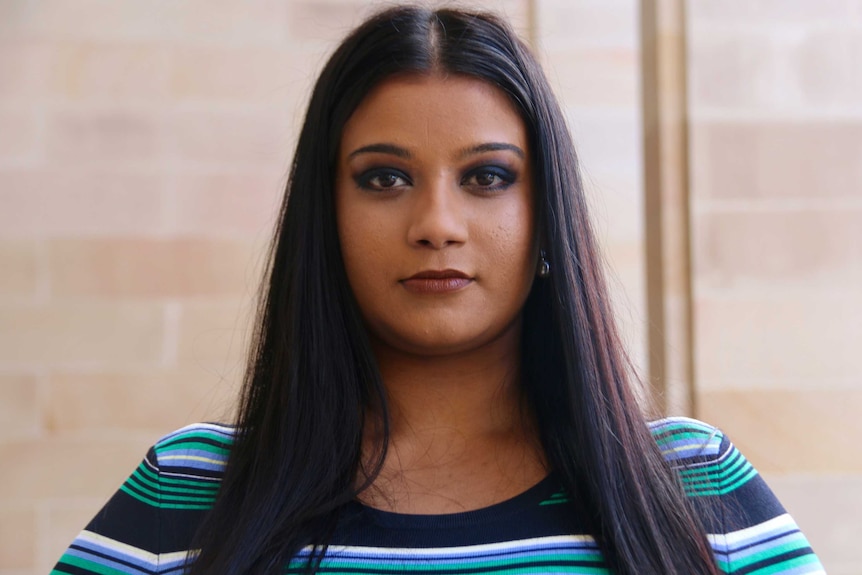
190;7;717;575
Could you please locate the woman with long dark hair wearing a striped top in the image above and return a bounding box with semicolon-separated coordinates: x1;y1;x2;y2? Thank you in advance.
50;7;822;575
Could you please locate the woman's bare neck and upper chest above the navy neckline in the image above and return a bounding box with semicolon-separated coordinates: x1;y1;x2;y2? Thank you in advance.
361;329;547;513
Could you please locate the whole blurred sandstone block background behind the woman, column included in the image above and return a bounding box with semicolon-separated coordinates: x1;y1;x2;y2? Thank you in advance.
0;0;862;575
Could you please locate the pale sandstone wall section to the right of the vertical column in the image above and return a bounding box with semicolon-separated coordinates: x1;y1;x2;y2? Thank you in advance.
687;0;862;575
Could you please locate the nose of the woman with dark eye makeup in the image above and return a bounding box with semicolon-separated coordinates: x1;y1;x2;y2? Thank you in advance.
407;177;467;250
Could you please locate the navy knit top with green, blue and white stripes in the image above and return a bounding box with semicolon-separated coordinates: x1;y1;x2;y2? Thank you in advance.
52;418;824;575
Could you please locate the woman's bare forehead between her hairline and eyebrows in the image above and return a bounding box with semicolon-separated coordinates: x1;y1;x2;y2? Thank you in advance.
341;74;527;155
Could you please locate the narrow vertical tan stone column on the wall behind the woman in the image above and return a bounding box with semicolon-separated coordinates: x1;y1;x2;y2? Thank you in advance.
640;0;695;415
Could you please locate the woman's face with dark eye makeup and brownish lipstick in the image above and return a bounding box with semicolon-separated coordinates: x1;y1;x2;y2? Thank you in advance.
335;75;537;355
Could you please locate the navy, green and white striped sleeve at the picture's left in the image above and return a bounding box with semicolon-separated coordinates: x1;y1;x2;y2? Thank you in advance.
52;423;228;575
